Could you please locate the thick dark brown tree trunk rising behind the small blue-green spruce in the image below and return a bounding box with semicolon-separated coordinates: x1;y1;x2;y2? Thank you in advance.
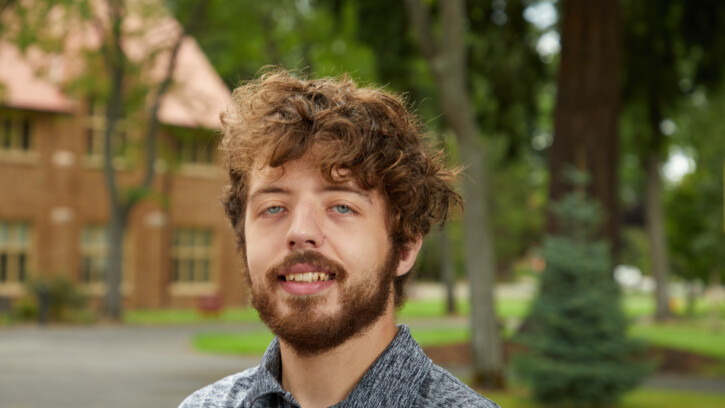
547;0;621;253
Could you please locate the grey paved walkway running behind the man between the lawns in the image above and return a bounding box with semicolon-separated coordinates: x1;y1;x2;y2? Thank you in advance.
0;319;725;408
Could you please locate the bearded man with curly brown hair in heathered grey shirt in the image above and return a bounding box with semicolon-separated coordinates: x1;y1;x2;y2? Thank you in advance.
181;70;496;408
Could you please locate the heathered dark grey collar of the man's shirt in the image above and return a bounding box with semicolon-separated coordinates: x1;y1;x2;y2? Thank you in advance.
240;325;433;408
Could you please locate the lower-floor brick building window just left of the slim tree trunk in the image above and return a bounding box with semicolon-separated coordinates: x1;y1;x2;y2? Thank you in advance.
81;225;108;283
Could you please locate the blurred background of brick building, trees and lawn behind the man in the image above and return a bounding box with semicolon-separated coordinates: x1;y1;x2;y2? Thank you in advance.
0;0;725;407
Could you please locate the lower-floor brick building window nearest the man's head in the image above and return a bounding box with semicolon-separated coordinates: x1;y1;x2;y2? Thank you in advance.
171;228;212;283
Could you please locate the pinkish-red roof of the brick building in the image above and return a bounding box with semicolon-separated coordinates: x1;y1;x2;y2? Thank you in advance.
0;3;231;129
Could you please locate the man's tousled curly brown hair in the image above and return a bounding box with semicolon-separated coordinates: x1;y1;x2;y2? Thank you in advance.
221;68;462;306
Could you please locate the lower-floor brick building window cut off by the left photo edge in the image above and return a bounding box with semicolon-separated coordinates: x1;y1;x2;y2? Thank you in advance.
0;221;30;284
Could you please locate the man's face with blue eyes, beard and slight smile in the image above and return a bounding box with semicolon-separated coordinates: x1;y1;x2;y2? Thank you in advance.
244;155;410;355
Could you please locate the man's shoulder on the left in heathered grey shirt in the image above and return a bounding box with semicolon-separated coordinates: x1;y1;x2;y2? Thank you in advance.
179;366;259;408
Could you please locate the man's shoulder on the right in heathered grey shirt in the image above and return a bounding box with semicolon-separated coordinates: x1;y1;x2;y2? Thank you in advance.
418;364;498;408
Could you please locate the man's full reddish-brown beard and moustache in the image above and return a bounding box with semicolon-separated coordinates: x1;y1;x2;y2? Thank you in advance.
245;248;400;356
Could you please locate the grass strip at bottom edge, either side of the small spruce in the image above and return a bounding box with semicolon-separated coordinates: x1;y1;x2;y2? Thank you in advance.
483;388;725;408
